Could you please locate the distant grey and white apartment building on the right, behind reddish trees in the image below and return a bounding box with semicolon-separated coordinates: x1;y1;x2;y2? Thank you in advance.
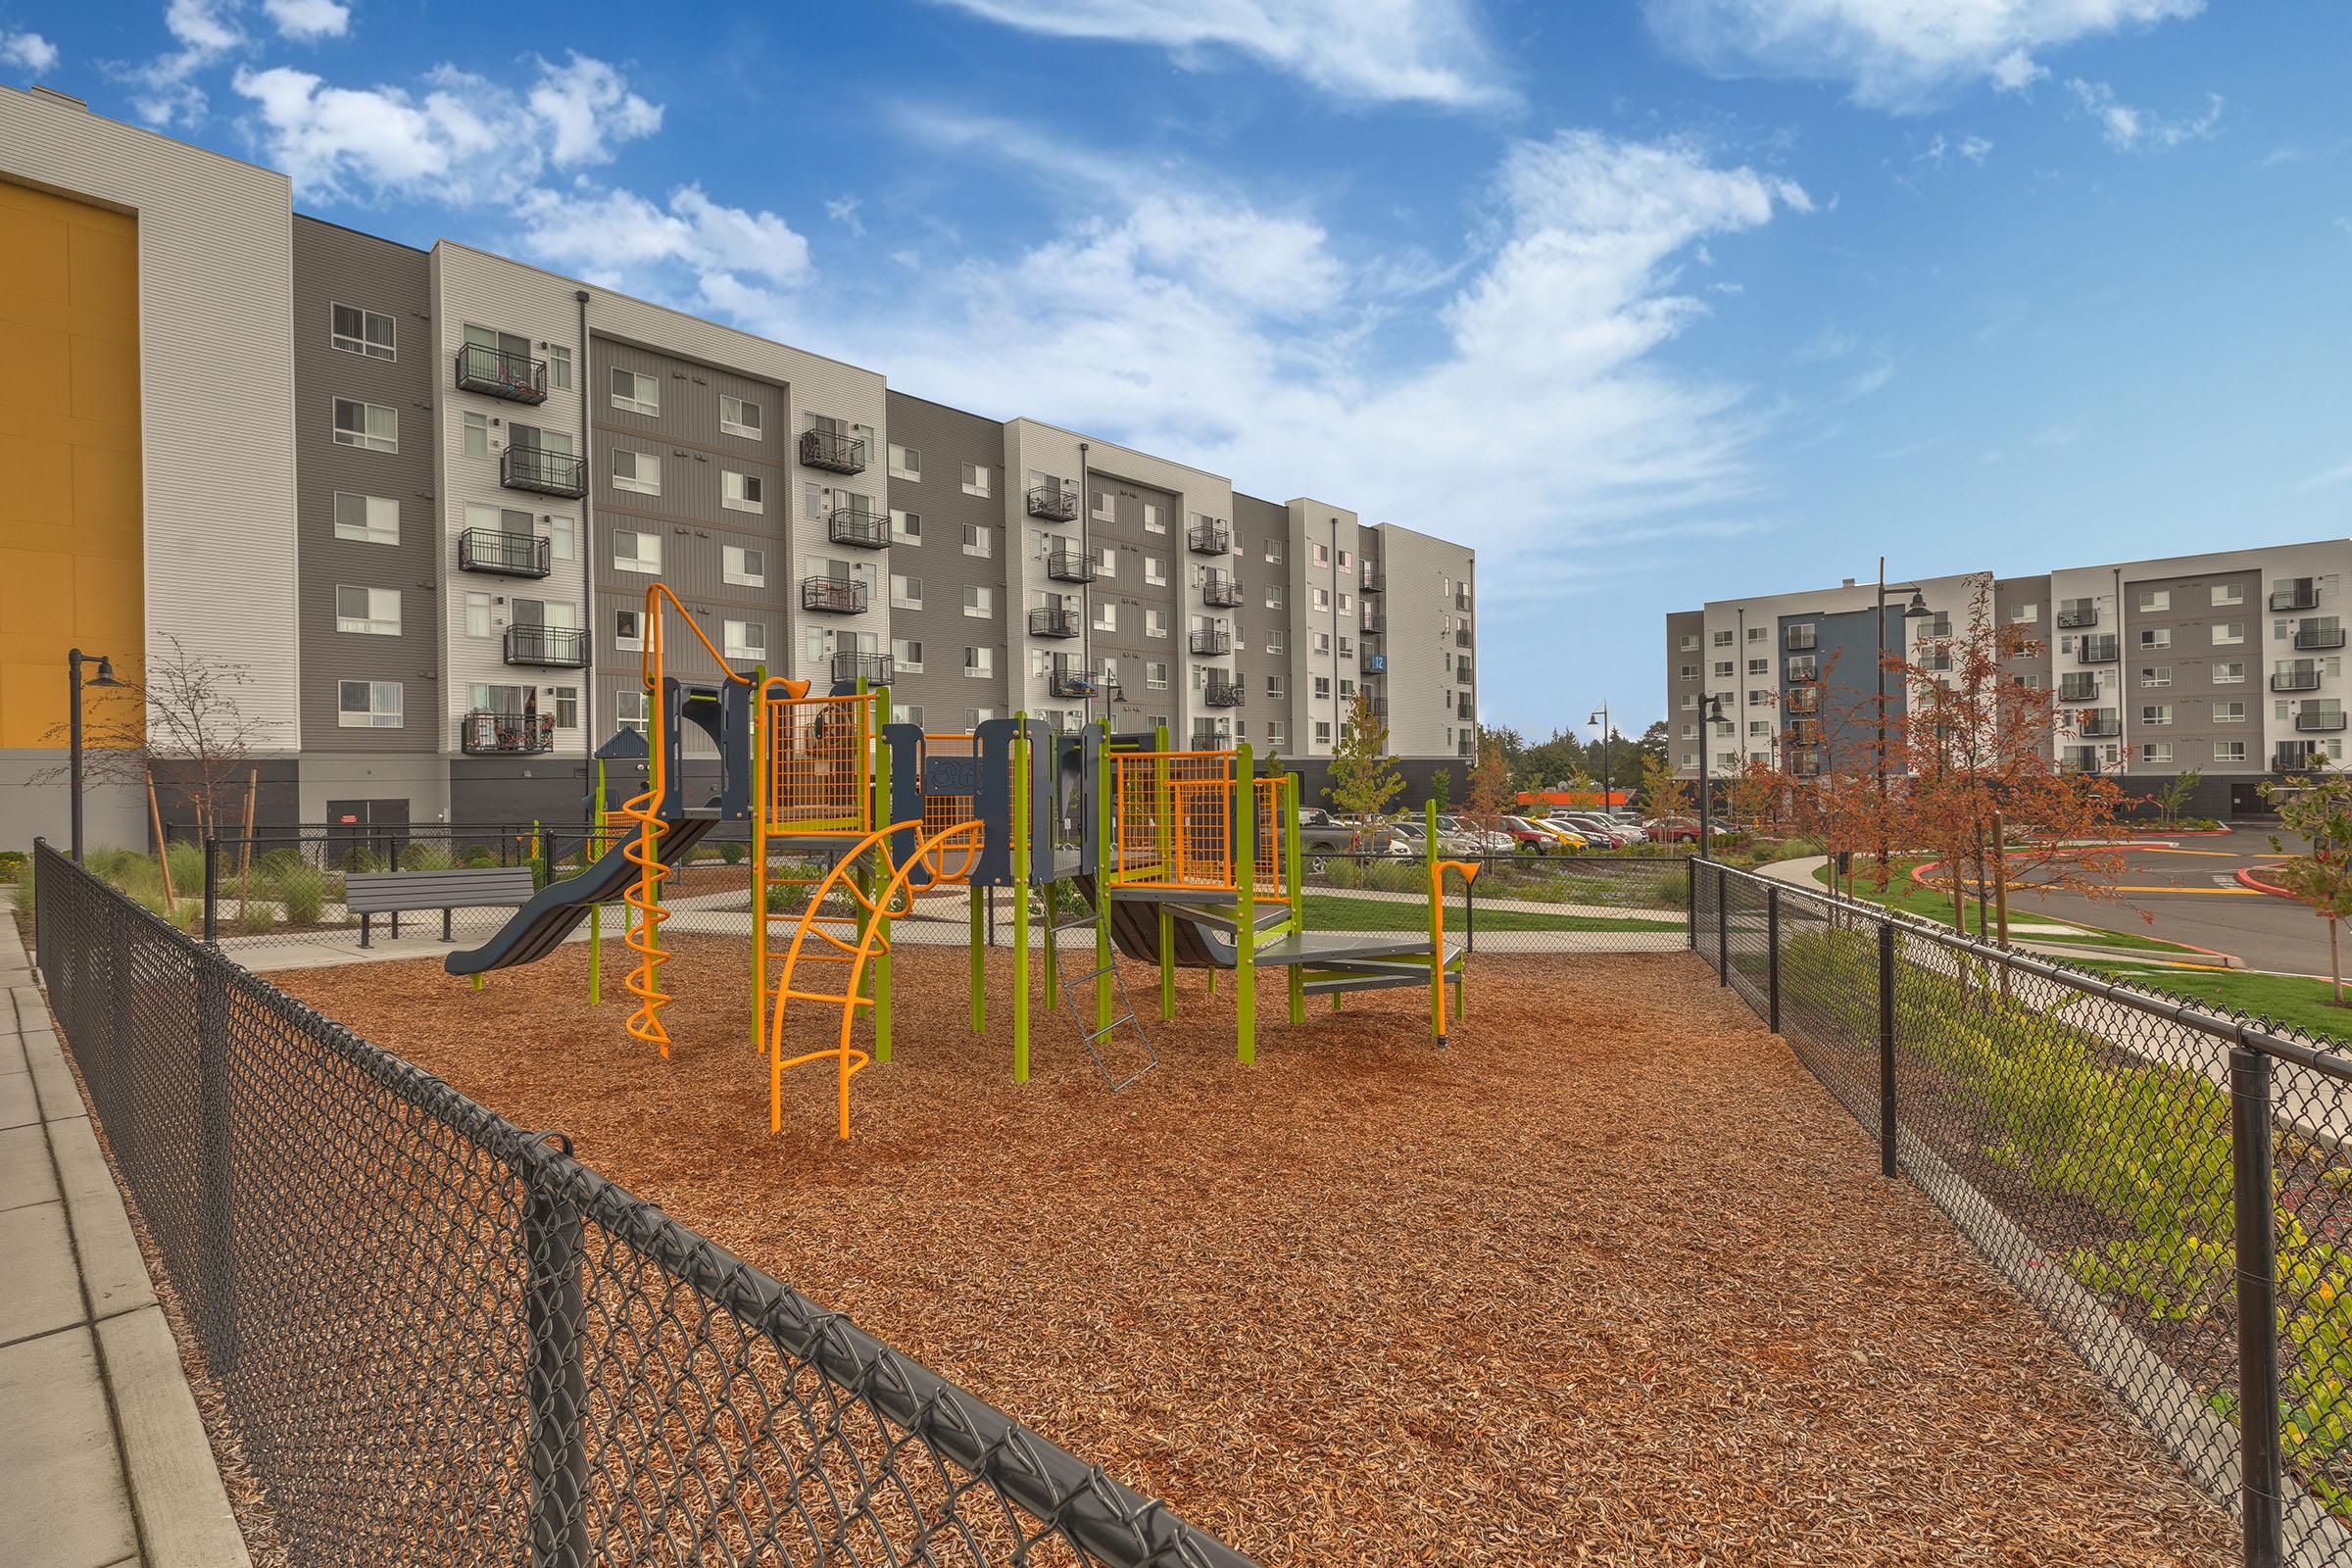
1665;541;2352;815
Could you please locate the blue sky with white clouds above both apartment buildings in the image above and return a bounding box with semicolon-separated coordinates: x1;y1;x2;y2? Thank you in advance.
0;0;2352;733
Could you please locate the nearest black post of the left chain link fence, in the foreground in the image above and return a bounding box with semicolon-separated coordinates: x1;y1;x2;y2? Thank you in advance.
522;1133;588;1568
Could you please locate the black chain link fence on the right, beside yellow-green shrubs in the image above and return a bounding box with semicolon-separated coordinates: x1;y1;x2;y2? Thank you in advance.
1691;862;2352;1566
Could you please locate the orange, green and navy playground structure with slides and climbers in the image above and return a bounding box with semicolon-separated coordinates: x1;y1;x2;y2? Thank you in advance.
445;585;1477;1138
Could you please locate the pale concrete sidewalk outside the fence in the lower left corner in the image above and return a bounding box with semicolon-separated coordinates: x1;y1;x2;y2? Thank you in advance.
0;917;249;1568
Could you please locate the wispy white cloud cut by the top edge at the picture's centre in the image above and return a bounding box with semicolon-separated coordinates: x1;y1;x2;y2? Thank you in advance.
917;0;1517;108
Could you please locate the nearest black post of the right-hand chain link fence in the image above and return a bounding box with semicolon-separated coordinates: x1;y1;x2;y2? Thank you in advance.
2230;1046;2283;1568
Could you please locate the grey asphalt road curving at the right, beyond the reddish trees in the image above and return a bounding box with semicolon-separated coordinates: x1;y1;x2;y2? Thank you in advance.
2009;827;2352;976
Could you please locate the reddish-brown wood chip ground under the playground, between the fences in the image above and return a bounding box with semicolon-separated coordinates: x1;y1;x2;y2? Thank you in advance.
280;936;2236;1568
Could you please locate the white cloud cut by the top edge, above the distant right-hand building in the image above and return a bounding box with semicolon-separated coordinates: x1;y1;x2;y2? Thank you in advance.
1646;0;2204;111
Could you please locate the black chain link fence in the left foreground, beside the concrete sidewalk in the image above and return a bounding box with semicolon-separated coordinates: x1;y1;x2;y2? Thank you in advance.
35;844;1247;1568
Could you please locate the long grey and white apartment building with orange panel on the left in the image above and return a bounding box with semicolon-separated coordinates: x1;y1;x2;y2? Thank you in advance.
0;89;1477;844
